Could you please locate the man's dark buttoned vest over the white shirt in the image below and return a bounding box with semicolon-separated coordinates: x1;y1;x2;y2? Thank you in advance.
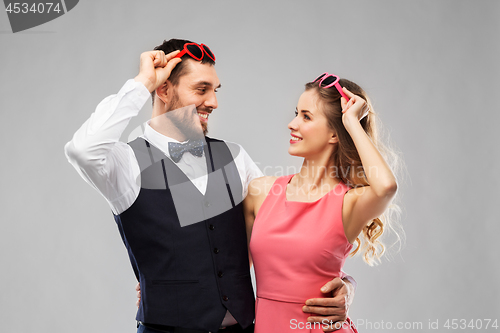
115;137;255;331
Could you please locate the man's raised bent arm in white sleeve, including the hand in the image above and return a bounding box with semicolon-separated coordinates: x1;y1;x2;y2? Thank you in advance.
64;51;181;214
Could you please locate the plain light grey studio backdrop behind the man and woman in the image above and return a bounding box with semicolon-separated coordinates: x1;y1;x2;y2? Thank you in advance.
0;0;500;333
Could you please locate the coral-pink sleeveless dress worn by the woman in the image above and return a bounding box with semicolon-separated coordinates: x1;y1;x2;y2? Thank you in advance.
250;175;357;333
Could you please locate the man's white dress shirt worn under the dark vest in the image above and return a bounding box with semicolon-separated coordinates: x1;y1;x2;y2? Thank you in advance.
64;79;263;215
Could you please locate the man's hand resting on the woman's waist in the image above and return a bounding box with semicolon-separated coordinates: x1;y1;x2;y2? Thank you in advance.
302;277;354;332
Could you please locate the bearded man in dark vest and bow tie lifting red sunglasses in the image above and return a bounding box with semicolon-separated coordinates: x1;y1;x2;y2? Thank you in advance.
65;39;352;333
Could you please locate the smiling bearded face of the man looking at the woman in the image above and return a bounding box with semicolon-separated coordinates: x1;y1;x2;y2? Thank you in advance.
168;59;220;134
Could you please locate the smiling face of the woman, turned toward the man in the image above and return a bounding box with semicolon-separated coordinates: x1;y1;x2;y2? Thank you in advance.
288;90;337;158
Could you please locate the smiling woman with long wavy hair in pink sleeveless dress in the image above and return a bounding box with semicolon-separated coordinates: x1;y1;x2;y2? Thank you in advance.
244;73;397;333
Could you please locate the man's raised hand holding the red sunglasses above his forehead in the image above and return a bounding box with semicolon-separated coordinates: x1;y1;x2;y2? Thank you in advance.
134;50;182;92
